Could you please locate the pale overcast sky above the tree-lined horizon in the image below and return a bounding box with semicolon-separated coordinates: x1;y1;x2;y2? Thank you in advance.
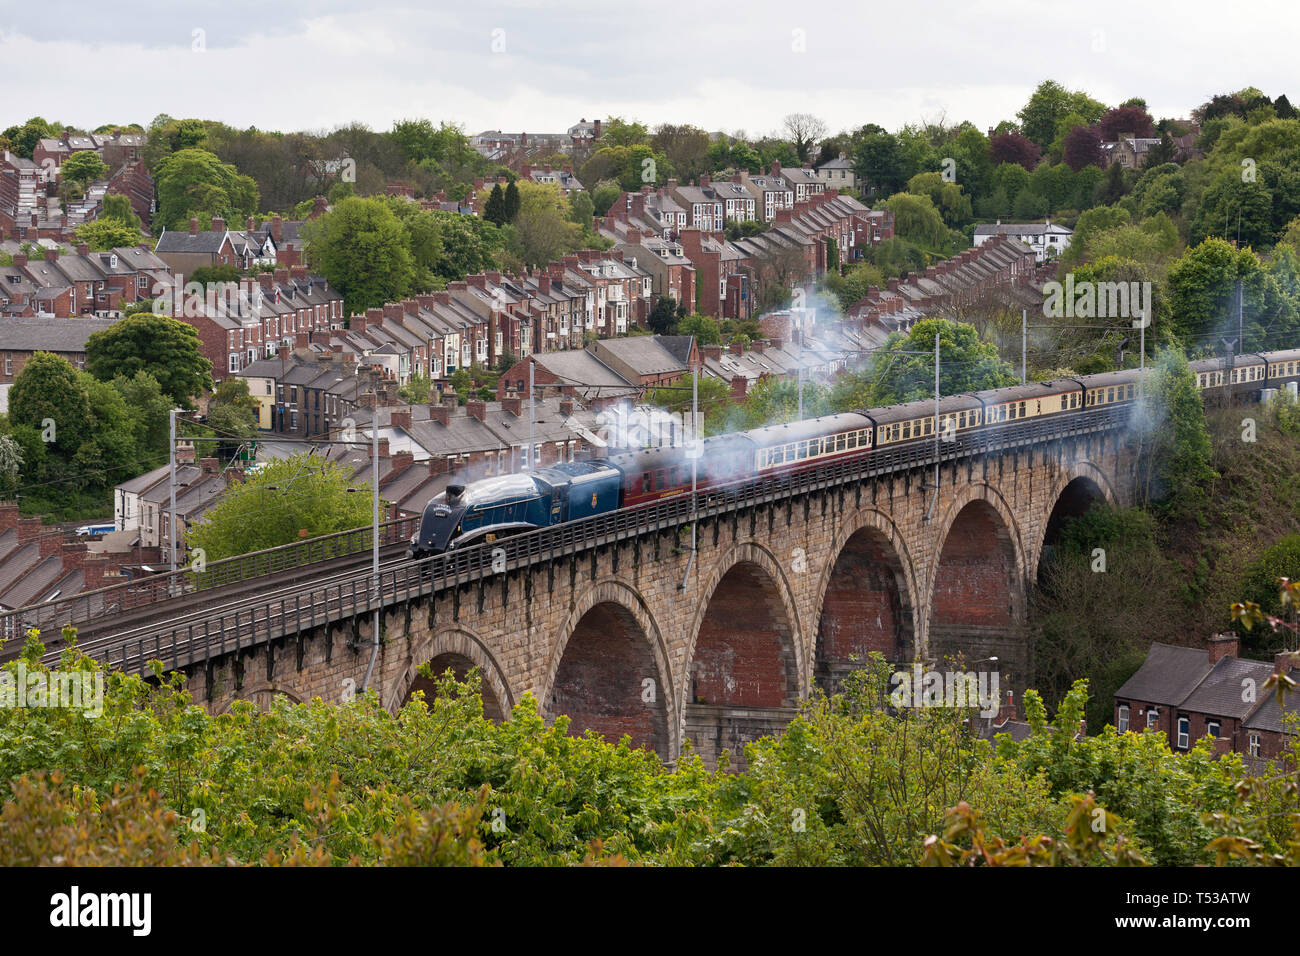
0;0;1300;135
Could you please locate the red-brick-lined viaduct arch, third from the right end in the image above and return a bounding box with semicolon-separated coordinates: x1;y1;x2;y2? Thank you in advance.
813;509;922;692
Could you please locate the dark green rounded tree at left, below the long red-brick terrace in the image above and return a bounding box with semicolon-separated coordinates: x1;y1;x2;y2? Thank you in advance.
86;315;212;408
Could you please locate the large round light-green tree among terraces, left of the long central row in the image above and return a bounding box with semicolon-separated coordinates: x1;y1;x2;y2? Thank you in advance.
300;196;413;315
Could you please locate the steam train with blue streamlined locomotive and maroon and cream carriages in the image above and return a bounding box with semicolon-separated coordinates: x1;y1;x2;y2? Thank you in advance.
407;349;1300;557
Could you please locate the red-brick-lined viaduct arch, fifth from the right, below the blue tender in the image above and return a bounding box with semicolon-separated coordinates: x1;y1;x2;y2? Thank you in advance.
540;578;680;760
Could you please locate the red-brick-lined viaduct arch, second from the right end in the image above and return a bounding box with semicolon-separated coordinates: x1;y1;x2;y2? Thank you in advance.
918;483;1027;670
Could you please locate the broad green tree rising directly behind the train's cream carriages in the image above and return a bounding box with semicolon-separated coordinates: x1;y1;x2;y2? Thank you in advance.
831;319;1019;411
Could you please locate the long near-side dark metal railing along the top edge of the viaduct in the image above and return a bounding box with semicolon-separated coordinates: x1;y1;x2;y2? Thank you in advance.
48;406;1130;674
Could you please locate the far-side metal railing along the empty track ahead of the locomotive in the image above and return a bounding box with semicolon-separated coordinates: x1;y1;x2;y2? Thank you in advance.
0;516;420;641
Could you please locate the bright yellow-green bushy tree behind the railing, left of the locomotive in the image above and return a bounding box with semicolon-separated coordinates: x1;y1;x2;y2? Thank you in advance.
186;454;371;561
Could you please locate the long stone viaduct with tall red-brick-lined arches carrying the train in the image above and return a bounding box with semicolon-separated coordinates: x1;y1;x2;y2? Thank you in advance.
182;428;1135;766
